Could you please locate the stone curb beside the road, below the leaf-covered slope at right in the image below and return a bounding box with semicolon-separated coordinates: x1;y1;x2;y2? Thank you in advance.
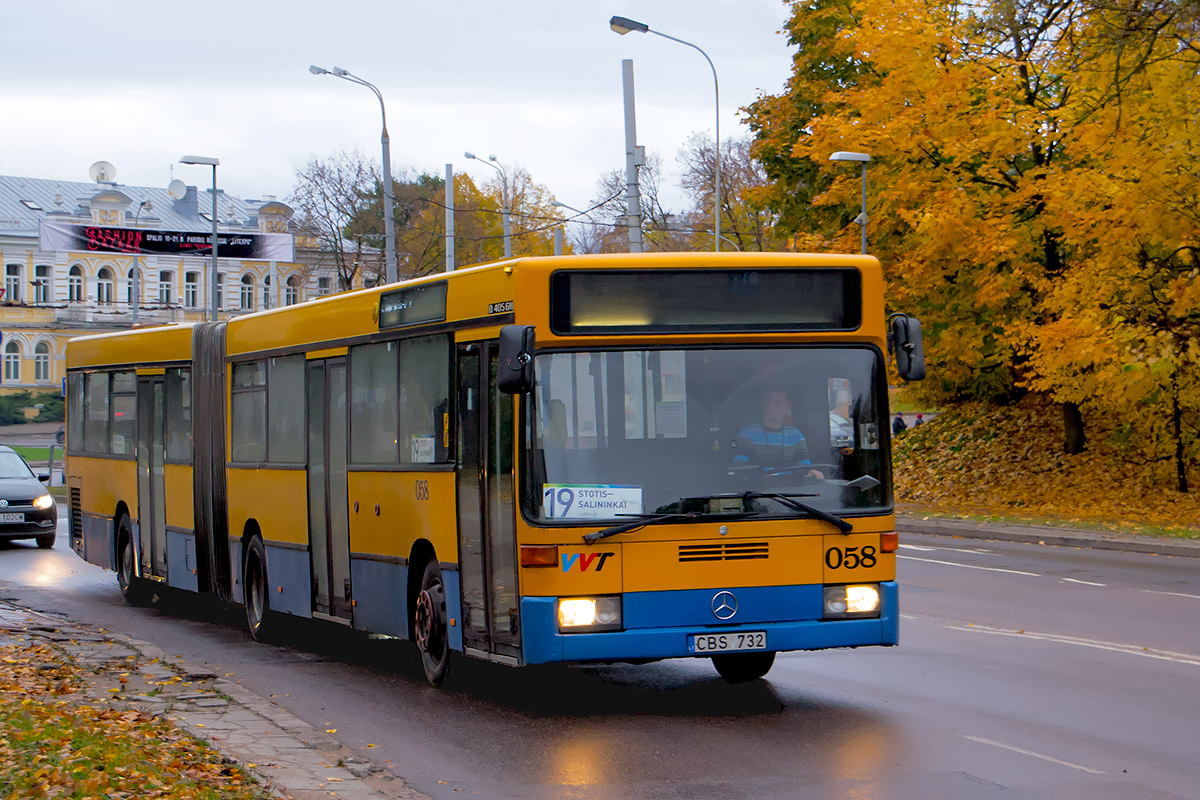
896;515;1200;558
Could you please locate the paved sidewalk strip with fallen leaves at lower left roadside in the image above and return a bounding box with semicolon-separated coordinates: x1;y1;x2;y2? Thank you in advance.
0;601;428;800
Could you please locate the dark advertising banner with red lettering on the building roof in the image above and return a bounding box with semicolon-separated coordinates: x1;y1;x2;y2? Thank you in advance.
38;219;295;261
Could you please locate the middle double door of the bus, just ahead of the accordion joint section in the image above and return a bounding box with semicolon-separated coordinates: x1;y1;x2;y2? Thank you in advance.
307;359;353;622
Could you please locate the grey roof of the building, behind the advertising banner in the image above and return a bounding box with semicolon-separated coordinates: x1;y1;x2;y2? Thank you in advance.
0;175;290;236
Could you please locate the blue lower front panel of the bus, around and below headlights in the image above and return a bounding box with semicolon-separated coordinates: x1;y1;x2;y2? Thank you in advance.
521;582;899;663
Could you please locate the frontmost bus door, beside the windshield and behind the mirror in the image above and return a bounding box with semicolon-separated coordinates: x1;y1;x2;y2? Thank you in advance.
456;343;521;663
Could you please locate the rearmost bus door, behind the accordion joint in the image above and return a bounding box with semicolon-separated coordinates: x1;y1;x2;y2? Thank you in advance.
136;375;168;583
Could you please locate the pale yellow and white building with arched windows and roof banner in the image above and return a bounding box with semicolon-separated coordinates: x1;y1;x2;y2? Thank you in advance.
0;175;336;392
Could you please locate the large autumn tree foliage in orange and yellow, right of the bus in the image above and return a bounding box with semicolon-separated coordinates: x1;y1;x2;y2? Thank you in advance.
748;0;1200;492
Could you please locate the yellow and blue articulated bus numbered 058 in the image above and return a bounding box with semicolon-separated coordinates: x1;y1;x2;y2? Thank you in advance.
67;253;924;684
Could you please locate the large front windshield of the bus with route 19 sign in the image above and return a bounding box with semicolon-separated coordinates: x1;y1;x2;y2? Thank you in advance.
523;347;892;524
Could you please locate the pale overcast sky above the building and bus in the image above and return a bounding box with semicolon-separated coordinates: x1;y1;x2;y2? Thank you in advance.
9;0;791;207
